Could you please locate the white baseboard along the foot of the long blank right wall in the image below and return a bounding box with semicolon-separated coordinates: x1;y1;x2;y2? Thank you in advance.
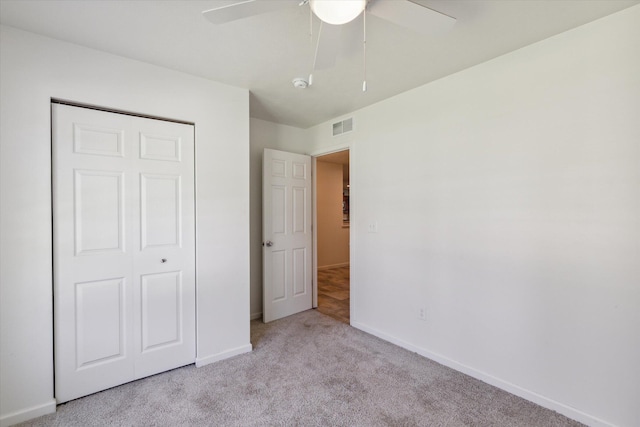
351;321;614;427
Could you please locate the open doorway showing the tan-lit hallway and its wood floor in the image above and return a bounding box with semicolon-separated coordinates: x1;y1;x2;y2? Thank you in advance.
316;150;351;324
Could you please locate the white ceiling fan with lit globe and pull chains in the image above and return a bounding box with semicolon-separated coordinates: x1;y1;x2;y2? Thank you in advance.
202;0;456;91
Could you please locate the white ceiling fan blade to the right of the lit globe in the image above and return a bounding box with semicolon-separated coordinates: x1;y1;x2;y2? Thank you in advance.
367;0;456;35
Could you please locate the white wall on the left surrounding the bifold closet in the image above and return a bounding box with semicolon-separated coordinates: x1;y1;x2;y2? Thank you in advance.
0;26;251;425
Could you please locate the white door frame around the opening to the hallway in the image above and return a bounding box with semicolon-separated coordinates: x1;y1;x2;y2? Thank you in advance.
309;143;353;316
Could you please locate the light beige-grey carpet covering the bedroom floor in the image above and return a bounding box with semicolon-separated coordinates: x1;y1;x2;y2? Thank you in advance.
24;310;580;426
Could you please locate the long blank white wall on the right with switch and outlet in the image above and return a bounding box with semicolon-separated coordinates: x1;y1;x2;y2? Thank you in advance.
309;6;640;426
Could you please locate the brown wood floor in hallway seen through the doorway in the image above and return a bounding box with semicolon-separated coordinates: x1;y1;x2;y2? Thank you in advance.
318;266;350;324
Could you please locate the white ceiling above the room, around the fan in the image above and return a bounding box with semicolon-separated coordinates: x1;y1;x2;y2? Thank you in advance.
0;0;640;128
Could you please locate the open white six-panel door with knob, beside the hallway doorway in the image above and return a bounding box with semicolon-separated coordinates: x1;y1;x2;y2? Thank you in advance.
262;149;313;322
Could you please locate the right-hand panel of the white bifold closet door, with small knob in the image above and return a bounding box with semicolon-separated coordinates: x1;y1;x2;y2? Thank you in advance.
133;118;196;378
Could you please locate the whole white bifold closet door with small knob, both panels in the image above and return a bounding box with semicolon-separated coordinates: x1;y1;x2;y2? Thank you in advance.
52;104;196;403
